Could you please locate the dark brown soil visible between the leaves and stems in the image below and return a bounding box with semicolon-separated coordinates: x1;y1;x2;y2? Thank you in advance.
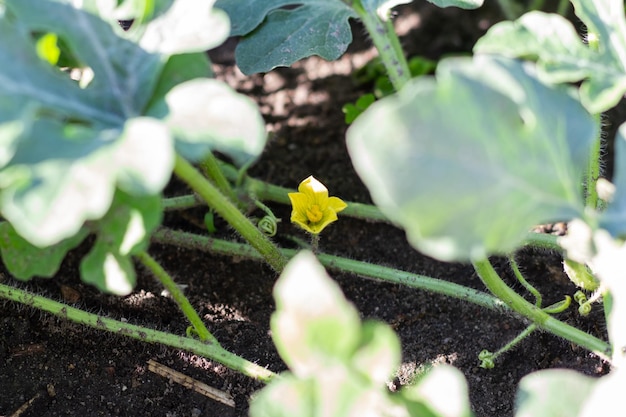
0;2;624;417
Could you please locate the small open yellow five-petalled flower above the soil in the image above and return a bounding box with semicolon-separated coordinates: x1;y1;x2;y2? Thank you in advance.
289;176;348;235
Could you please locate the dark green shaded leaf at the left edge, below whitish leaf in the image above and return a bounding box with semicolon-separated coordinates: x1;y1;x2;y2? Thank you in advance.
0;222;87;280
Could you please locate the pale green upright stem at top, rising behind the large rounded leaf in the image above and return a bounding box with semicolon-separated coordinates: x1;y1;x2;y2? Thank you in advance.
352;0;411;91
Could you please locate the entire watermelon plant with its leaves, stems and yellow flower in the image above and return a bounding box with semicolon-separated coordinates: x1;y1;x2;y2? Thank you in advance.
0;0;626;416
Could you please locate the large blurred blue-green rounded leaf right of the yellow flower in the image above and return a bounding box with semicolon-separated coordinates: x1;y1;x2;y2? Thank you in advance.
347;56;598;260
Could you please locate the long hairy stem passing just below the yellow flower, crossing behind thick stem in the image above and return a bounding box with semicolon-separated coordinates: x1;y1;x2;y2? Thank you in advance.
152;228;507;311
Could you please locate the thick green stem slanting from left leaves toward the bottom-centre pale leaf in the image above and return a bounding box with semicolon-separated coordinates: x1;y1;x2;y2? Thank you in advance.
174;155;287;272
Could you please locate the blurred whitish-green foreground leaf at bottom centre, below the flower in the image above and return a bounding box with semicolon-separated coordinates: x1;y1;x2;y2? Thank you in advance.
250;252;470;417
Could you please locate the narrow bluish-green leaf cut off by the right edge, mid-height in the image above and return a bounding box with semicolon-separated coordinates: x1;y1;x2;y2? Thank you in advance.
600;123;626;238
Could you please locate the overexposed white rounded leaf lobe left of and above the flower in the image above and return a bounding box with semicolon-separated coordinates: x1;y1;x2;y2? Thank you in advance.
150;79;267;166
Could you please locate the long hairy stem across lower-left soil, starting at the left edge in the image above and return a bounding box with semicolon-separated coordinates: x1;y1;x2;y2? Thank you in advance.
0;284;276;382
